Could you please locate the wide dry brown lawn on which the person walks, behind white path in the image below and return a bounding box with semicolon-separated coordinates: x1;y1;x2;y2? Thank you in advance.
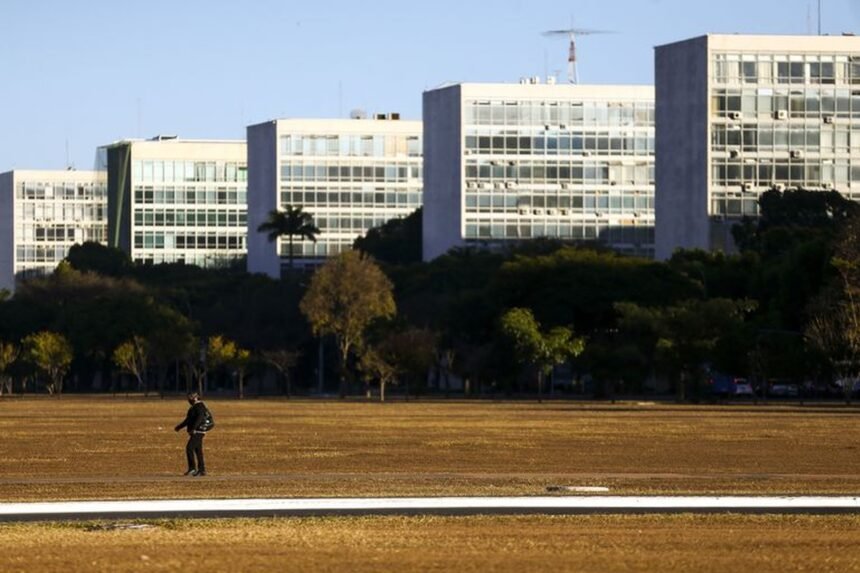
0;397;860;501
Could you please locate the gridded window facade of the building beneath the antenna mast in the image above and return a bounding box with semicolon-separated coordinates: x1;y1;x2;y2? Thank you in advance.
462;94;654;257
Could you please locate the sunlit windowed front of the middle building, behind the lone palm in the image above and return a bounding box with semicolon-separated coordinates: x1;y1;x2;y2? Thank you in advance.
278;128;423;259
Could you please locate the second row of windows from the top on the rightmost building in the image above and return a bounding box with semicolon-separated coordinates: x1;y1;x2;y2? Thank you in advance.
711;88;860;120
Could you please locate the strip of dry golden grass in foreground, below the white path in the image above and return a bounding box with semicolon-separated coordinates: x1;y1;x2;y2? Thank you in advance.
0;515;860;573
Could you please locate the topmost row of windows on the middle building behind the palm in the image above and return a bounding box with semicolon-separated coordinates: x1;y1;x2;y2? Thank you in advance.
280;135;423;157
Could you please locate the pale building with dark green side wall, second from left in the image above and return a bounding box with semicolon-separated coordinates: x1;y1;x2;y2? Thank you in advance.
101;136;248;267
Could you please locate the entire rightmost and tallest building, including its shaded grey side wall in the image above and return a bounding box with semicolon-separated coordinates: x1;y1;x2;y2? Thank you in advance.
655;35;860;259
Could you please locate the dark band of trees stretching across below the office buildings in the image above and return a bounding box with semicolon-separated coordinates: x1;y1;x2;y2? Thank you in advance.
0;190;860;400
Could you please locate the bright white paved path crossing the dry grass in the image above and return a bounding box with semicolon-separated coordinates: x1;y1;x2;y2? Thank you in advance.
0;496;860;521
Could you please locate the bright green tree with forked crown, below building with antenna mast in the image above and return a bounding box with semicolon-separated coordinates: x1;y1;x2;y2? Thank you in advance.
501;308;585;400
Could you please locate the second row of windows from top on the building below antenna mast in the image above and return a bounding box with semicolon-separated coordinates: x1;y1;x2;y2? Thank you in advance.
466;131;654;155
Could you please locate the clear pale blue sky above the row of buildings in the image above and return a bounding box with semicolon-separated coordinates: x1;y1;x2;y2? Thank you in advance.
0;0;860;171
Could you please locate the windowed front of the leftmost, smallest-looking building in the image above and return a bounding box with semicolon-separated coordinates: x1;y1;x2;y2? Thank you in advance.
14;177;107;278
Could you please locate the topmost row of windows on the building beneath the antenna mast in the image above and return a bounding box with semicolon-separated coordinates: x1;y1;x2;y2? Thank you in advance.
463;101;654;127
